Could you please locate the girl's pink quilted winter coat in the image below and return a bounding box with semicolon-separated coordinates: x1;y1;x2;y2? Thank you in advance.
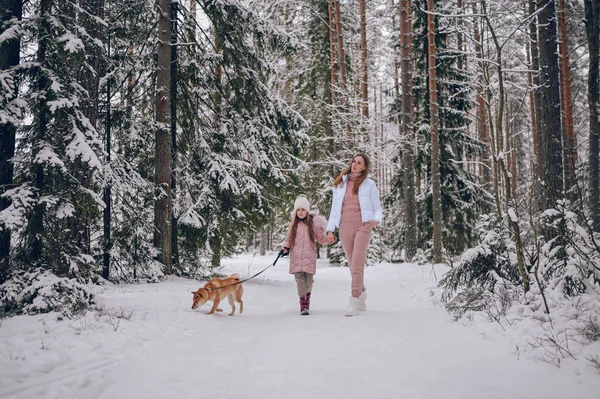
282;215;328;274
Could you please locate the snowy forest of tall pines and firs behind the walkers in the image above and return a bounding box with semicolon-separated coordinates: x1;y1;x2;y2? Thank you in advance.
0;0;600;320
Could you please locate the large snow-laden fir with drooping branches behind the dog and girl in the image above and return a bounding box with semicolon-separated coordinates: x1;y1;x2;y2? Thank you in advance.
177;1;302;266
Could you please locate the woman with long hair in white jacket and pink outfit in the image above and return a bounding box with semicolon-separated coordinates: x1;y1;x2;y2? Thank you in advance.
327;154;383;316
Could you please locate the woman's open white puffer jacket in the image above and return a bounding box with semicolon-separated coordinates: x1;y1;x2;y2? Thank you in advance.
326;175;383;231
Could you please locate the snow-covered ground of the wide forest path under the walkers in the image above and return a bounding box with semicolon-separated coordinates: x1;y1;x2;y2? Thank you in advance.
0;255;600;399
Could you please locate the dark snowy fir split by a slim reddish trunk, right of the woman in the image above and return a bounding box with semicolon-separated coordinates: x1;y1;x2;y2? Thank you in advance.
412;3;486;254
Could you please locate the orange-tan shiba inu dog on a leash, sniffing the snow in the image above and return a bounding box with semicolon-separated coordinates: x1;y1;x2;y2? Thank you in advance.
192;273;244;316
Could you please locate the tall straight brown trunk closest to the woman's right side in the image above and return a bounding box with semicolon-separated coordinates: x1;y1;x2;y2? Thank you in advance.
399;0;417;261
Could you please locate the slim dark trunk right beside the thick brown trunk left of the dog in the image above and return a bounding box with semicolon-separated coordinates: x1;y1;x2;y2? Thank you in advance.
169;2;179;274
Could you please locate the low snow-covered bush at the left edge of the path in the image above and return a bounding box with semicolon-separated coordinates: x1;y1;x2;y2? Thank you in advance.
0;271;95;316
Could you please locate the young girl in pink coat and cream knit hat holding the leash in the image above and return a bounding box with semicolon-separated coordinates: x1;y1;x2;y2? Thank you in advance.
281;195;328;315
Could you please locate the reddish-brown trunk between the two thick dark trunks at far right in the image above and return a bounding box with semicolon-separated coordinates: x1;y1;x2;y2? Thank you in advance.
558;0;577;194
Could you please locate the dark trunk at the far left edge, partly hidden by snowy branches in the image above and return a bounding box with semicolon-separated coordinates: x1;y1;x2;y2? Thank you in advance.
0;0;23;284
